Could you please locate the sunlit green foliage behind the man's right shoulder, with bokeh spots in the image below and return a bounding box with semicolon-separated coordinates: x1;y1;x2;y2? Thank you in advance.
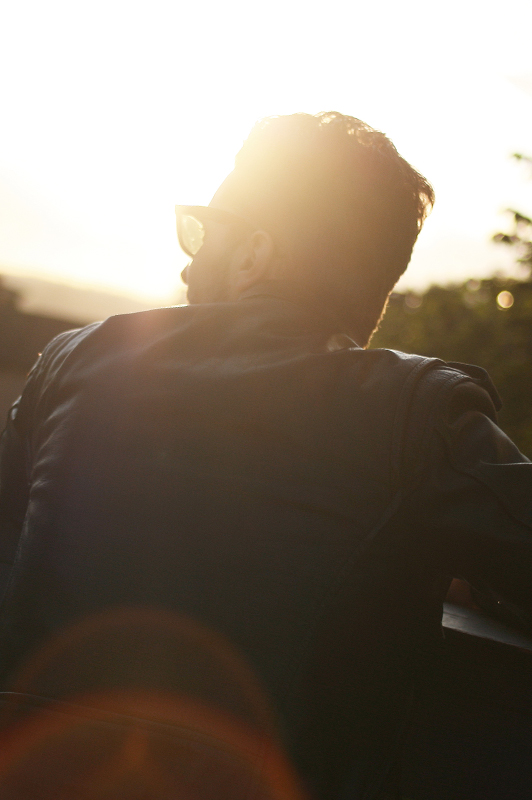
371;278;532;457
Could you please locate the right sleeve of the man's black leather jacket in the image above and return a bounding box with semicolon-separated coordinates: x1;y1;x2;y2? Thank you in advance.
408;368;532;615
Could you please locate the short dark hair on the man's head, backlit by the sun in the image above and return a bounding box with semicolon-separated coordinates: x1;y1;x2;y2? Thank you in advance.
222;111;434;347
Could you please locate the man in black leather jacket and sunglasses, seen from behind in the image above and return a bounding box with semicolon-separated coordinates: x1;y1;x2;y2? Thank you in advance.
0;113;532;798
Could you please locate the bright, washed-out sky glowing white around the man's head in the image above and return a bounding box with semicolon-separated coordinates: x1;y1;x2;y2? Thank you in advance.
0;0;532;305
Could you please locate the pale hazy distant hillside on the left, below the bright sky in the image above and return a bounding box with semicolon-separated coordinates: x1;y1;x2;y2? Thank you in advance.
0;269;185;324
